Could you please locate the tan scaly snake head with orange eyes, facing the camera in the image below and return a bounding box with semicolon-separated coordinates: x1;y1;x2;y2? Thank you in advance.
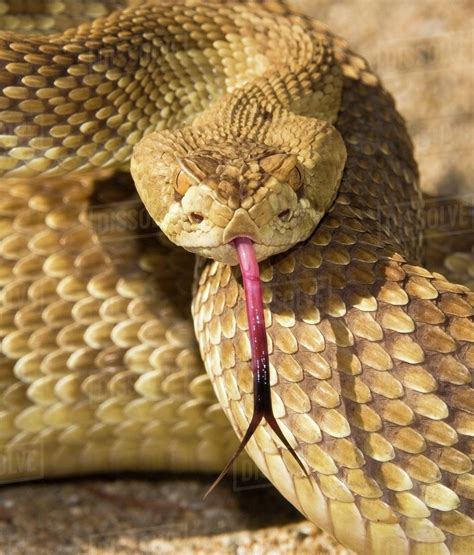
131;118;345;265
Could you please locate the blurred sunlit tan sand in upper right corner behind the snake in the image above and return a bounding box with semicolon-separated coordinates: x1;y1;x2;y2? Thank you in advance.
302;0;474;197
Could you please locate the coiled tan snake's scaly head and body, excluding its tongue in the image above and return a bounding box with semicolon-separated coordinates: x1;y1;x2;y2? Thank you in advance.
0;0;474;554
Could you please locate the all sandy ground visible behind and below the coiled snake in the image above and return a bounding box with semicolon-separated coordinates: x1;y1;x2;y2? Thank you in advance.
0;0;474;555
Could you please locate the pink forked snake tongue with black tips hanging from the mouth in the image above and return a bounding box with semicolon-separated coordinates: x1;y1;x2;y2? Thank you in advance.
204;237;308;498
